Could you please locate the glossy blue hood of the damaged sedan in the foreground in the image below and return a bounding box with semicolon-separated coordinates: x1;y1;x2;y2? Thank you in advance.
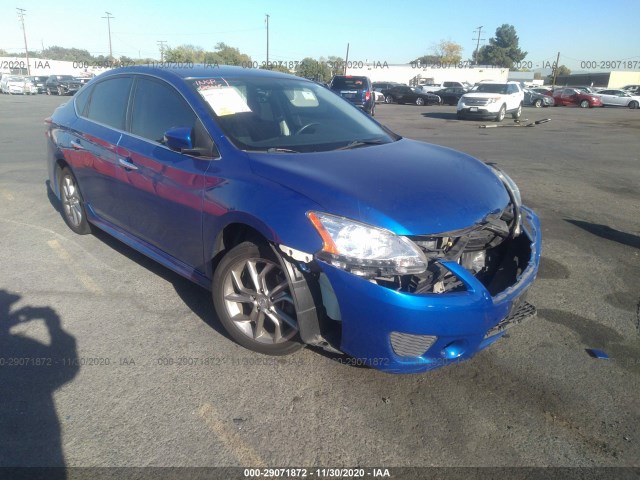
249;139;509;235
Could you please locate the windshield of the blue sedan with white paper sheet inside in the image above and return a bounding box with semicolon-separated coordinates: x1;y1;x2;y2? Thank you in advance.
187;76;400;153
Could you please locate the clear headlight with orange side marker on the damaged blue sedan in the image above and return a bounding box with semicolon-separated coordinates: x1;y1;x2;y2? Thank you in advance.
307;212;427;278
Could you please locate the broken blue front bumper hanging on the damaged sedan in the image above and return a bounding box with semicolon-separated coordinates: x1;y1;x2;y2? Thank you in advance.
319;207;541;373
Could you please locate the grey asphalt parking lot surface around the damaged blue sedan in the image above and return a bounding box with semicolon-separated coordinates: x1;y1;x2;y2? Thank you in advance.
0;95;640;467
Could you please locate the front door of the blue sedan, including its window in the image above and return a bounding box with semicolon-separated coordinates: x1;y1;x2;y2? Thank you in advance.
117;75;211;271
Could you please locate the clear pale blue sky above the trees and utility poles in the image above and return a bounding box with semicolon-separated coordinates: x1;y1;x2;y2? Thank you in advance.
0;0;640;71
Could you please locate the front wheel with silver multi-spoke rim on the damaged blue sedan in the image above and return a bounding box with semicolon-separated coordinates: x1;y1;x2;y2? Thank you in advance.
212;241;303;355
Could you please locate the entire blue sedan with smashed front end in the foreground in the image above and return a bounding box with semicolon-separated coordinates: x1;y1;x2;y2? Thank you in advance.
46;66;541;373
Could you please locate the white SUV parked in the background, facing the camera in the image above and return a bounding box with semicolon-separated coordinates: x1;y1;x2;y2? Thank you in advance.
457;82;524;122
